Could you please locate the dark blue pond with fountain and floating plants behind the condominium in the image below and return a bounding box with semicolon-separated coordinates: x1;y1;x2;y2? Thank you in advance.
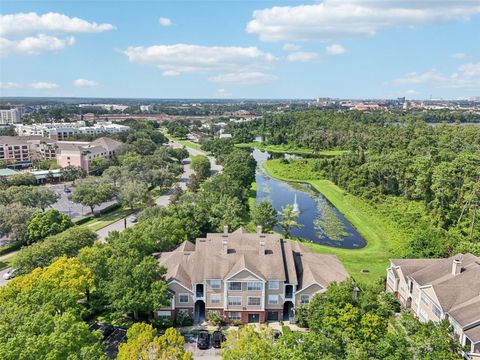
253;149;366;249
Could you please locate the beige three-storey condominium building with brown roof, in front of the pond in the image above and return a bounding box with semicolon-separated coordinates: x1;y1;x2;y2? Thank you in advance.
155;227;348;323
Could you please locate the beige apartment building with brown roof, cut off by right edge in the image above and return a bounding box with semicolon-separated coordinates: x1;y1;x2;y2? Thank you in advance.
386;254;480;360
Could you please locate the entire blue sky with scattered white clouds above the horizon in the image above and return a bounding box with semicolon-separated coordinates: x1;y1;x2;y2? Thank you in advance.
0;0;480;99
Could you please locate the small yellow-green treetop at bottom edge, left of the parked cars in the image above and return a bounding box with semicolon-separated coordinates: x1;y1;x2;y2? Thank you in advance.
117;323;193;360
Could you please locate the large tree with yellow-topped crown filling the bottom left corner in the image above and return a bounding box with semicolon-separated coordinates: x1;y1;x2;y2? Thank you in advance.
0;257;105;360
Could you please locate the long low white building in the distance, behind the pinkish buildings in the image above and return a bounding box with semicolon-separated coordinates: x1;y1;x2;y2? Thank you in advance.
15;121;130;141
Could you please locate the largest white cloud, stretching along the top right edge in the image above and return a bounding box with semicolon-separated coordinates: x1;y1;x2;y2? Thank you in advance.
246;0;480;41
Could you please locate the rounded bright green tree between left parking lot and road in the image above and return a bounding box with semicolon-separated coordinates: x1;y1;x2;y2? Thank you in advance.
27;209;73;242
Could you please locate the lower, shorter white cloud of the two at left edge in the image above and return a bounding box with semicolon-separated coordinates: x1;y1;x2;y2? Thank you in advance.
0;34;75;56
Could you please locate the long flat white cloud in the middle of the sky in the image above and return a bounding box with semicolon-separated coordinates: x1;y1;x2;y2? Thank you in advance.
123;44;277;83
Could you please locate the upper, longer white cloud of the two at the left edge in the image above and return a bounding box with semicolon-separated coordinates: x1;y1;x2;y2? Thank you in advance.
0;12;115;36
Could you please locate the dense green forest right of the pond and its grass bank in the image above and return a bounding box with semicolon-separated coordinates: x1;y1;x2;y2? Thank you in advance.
233;111;480;256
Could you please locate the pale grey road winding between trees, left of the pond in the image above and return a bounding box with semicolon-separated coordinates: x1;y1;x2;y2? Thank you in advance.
97;142;222;241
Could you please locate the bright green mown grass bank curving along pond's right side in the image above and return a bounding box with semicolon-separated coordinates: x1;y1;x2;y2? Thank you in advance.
263;160;406;283
